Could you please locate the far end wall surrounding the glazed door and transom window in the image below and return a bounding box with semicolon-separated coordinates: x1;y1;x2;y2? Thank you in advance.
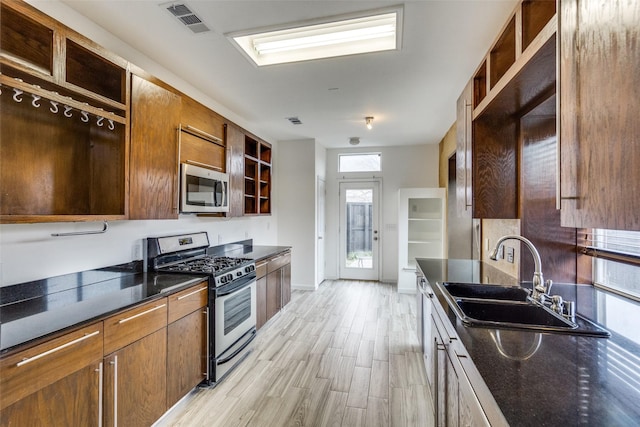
326;144;439;283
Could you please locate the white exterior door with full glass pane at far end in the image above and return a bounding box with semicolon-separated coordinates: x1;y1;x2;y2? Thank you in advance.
340;181;380;280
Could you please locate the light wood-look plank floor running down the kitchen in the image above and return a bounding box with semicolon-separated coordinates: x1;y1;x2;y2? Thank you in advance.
157;281;433;427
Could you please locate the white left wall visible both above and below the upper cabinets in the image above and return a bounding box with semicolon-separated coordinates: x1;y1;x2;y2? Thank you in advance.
0;0;278;286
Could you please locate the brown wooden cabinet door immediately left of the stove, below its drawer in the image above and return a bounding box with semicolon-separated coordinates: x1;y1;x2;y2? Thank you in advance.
167;308;207;408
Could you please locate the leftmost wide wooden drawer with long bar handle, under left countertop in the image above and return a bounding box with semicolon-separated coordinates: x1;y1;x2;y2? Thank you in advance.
0;322;103;409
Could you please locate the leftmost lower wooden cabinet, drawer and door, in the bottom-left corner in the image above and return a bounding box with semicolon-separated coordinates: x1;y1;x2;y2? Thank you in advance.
0;322;103;426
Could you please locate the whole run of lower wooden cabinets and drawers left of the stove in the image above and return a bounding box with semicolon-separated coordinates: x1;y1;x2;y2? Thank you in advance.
0;280;208;427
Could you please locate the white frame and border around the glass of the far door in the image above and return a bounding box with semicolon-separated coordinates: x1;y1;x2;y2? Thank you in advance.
337;178;383;281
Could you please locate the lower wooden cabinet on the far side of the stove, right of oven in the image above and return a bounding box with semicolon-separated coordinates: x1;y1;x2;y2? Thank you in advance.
256;251;291;328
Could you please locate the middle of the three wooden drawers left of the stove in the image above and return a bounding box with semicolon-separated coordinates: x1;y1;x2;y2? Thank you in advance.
104;298;167;355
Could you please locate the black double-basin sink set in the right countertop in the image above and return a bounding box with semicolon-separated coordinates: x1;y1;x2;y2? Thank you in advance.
438;282;610;337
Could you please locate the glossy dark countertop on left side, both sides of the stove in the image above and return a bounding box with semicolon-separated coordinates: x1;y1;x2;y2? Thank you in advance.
0;244;291;355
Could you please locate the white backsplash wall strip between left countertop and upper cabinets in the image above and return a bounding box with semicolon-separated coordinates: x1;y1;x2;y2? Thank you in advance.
0;215;277;286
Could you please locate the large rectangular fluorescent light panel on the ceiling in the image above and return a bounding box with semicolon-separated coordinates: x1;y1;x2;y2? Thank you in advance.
226;7;402;66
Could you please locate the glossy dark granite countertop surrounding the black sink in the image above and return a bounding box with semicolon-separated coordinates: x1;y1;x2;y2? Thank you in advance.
418;259;640;426
